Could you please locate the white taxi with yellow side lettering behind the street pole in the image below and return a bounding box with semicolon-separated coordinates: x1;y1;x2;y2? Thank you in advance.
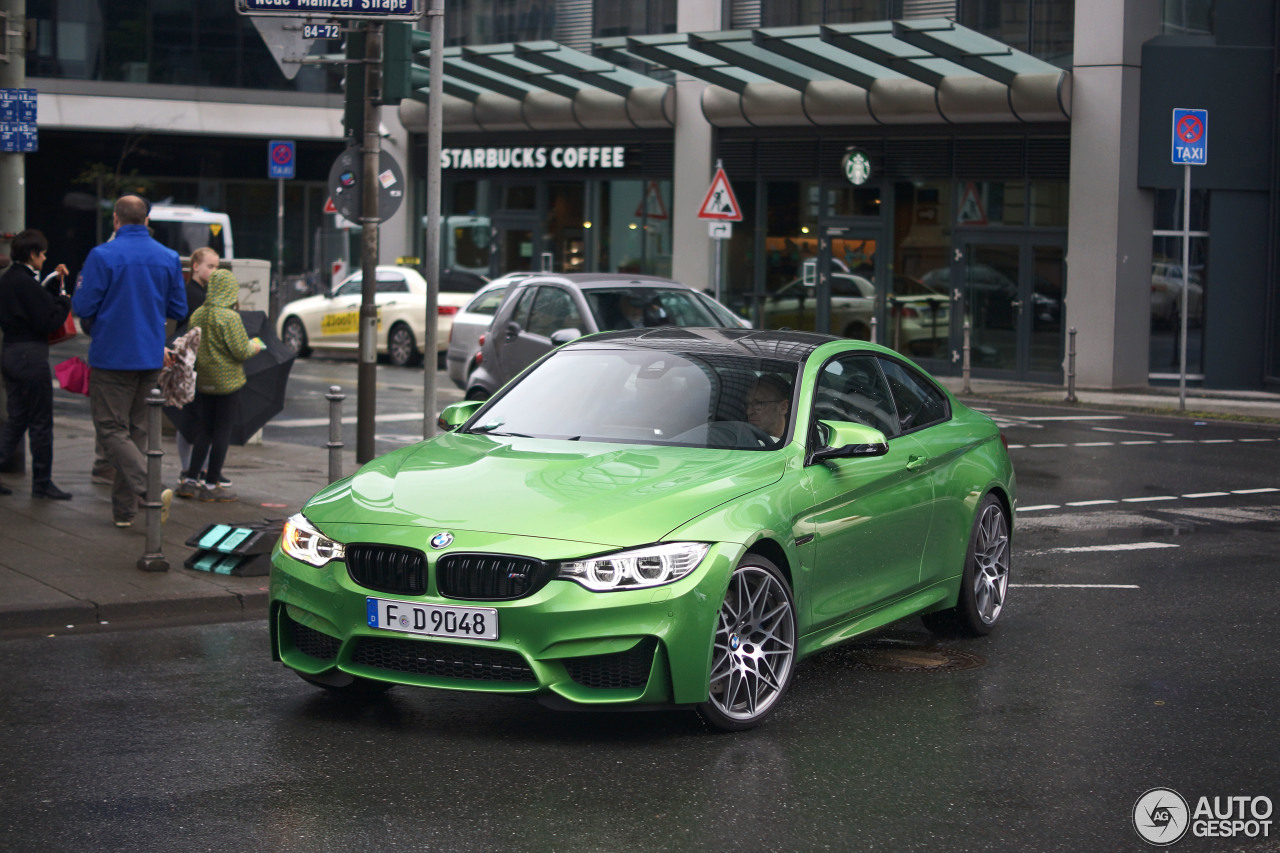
278;266;483;366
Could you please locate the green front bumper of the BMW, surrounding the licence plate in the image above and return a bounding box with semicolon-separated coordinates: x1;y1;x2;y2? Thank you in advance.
270;525;741;704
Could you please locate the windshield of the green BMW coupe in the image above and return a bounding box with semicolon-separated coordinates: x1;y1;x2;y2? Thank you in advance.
465;347;799;451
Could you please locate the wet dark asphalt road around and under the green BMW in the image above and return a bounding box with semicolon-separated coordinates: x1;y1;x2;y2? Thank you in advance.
0;406;1280;852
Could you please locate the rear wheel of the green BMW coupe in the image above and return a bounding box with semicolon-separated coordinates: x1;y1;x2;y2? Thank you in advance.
922;494;1009;637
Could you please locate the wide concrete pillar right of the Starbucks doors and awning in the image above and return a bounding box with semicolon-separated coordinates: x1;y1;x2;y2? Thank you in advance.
1066;0;1160;388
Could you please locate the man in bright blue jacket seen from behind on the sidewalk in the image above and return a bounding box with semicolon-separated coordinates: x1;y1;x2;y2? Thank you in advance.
72;196;187;528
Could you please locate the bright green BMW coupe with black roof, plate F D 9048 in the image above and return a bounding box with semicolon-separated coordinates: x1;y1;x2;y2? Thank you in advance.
270;328;1016;730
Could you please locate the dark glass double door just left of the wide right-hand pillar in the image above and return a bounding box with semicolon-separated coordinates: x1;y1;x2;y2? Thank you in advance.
952;234;1066;382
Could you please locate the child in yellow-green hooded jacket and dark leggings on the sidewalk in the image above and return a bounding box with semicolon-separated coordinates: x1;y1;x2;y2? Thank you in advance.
183;269;262;501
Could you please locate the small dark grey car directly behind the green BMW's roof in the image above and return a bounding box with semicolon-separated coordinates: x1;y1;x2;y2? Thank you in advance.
466;273;745;400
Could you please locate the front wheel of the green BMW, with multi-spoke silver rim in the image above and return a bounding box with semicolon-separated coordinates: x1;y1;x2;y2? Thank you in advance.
698;555;797;731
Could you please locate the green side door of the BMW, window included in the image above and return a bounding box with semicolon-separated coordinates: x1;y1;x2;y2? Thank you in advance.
805;353;933;629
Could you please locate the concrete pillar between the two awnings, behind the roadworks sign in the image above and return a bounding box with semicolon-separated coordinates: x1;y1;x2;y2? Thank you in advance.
671;0;721;291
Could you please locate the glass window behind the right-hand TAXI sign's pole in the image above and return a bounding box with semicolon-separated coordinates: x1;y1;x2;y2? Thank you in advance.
1147;237;1208;379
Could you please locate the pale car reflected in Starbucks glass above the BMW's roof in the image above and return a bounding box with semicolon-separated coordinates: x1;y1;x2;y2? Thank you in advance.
764;273;951;356
